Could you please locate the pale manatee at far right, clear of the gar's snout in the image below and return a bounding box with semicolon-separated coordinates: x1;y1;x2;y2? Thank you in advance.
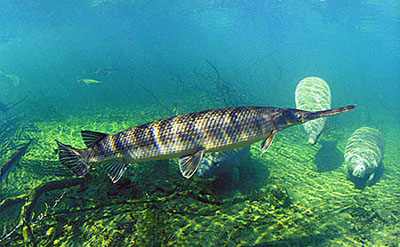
344;127;385;185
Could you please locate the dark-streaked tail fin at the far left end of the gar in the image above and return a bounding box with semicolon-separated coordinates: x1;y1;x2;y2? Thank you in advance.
56;140;89;176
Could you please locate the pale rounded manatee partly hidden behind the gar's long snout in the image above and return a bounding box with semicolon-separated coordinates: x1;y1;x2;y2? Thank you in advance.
296;77;331;144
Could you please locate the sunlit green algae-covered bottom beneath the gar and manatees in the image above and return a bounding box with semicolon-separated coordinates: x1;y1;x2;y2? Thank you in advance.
0;106;400;246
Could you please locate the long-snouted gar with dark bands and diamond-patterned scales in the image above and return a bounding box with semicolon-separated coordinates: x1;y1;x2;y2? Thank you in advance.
57;105;356;183
